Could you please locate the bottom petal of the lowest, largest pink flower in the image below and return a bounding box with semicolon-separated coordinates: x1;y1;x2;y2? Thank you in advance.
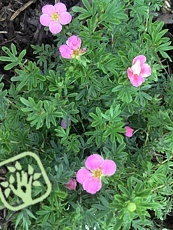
82;178;102;194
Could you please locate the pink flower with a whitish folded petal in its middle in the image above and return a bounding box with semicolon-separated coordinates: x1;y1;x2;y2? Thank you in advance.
127;55;151;87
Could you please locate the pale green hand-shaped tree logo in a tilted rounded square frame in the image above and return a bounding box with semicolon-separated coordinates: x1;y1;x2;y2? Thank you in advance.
0;152;51;211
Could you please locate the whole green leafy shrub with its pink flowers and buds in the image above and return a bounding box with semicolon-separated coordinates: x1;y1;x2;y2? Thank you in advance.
0;0;173;230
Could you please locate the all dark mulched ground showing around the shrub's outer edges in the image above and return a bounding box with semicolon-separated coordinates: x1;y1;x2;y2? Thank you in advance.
0;0;173;230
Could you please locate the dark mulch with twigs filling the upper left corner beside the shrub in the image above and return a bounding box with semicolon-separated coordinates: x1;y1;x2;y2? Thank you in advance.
0;0;80;88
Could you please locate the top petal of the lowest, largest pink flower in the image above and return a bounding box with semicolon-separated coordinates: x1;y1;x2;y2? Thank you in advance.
85;154;104;171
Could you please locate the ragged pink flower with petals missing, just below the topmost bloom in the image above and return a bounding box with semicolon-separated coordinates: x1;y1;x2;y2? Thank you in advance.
59;35;86;59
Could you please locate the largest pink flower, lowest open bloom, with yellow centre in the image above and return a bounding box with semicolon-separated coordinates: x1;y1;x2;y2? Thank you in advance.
76;154;116;194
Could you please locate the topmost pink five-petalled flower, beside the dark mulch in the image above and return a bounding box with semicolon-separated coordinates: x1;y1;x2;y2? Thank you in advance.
40;3;72;34
